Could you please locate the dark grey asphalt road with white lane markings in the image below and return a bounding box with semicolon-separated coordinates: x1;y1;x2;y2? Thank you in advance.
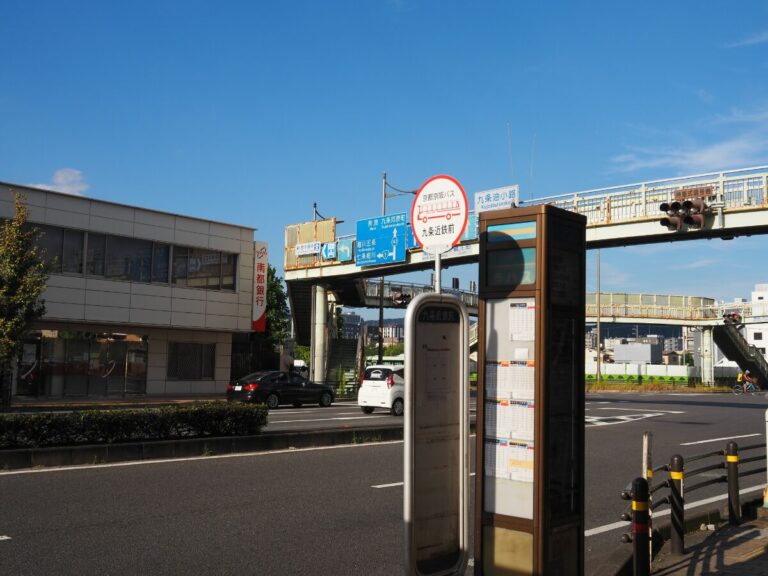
0;394;768;576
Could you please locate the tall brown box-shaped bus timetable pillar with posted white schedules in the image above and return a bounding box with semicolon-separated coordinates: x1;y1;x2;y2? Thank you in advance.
474;205;586;576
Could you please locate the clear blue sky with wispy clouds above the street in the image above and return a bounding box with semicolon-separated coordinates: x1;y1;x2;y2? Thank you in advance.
0;0;768;318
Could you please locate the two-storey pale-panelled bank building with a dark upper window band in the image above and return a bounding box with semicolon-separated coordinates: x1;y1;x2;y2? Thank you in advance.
0;182;258;398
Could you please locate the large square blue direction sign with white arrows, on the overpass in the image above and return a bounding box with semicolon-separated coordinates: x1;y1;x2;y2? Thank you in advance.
355;212;408;266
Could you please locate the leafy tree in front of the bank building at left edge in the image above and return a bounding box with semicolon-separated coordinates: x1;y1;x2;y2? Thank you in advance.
0;191;48;410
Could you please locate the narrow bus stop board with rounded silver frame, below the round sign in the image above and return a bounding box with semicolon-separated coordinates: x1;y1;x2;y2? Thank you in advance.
403;293;470;576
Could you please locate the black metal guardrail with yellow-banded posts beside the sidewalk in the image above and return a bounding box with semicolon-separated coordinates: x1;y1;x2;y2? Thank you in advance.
621;430;768;576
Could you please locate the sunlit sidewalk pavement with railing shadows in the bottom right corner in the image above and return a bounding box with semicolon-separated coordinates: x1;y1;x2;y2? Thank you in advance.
651;508;768;576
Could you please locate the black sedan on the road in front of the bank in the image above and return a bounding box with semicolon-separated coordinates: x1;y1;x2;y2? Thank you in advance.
227;370;334;408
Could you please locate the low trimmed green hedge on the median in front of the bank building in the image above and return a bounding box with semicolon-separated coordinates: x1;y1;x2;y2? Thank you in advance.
0;402;268;448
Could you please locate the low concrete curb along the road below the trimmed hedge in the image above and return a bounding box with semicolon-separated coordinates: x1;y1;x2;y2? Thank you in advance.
0;426;403;470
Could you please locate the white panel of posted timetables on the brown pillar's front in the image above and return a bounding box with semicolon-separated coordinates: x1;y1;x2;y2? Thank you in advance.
483;298;536;519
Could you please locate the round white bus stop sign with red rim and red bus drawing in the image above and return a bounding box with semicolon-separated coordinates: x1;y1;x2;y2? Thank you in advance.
411;175;469;254
